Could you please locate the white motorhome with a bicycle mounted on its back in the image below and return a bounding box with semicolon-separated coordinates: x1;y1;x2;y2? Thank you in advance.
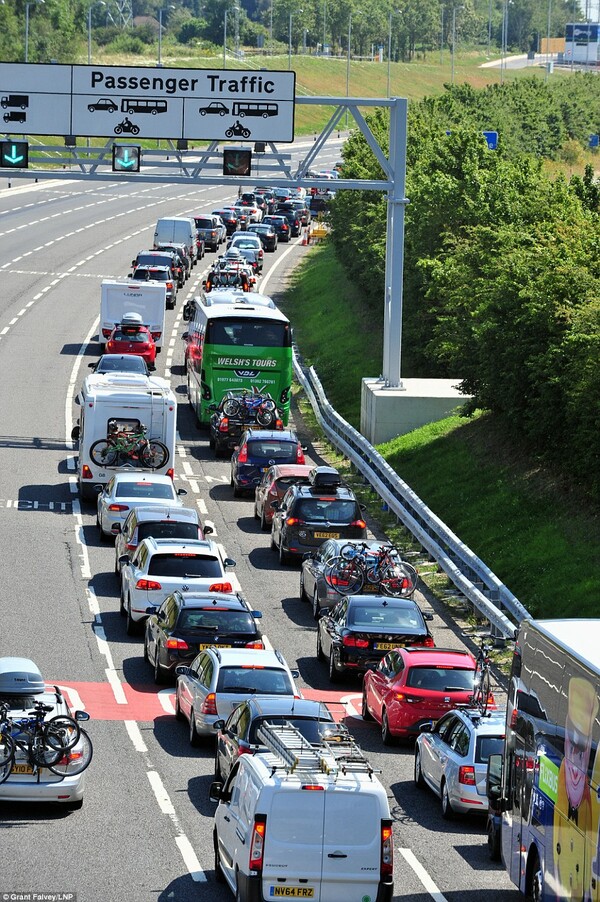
71;373;177;499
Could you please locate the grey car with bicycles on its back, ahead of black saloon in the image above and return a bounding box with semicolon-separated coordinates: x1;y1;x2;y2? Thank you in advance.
300;540;415;620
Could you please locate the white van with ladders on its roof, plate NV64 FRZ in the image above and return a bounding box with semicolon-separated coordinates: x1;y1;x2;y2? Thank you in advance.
210;724;394;902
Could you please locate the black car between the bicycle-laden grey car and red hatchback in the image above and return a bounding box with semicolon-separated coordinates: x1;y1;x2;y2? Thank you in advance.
317;595;434;683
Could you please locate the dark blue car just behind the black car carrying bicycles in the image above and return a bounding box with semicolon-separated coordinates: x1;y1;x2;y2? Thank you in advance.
231;429;306;498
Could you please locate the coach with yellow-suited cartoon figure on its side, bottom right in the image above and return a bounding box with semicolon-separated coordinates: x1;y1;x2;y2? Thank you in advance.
488;619;600;902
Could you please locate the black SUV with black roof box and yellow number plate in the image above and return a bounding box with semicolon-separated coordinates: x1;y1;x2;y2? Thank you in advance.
271;467;367;564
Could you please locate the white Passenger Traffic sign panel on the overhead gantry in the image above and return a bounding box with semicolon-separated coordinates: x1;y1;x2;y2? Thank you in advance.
0;63;296;142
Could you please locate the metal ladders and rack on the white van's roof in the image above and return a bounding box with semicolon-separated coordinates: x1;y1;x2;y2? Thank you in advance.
256;721;381;779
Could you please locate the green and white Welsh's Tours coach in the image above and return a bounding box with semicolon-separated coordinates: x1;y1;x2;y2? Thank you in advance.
183;289;292;425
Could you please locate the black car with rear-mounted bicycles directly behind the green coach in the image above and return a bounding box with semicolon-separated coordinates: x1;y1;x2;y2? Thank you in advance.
208;391;283;457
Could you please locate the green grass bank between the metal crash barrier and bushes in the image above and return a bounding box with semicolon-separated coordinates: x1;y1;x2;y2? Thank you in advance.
282;246;600;617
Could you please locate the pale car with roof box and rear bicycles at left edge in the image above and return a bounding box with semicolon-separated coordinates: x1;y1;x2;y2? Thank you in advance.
0;657;91;809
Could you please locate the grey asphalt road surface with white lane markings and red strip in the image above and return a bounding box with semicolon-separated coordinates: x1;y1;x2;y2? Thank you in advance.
0;143;518;902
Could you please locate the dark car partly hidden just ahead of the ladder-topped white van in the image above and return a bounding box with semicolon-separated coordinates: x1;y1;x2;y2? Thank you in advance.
214;695;336;783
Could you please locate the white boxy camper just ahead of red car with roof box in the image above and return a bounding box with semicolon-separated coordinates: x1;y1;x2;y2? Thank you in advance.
98;279;167;352
